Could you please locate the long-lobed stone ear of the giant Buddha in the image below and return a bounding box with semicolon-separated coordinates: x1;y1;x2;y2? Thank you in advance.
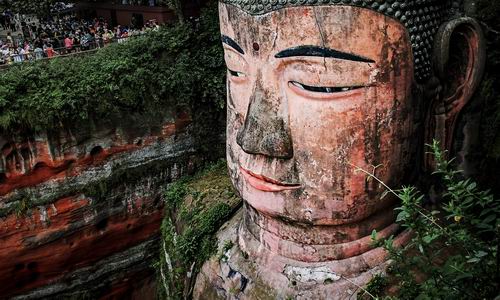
433;17;486;149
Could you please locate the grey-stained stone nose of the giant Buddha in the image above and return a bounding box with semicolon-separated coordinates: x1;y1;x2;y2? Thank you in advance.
236;79;293;159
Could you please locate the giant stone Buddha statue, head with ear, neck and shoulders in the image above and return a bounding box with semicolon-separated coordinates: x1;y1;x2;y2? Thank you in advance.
194;0;484;299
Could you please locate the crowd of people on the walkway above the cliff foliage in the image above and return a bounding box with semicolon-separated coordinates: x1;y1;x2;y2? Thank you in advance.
0;12;159;65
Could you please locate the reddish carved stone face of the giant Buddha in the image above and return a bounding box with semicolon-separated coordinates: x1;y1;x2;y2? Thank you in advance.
220;4;422;225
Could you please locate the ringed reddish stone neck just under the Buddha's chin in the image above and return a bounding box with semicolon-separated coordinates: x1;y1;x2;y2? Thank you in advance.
240;205;398;262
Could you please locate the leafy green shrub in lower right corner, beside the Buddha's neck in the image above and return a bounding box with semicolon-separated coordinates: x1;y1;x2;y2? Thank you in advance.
372;142;500;299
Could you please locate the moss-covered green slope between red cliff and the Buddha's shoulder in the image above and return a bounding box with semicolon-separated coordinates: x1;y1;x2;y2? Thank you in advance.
156;161;240;299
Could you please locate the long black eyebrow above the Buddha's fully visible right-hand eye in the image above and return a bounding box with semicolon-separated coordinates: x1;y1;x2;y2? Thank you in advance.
274;46;375;63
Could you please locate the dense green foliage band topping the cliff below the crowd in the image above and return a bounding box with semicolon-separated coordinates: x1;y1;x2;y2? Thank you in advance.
0;2;226;132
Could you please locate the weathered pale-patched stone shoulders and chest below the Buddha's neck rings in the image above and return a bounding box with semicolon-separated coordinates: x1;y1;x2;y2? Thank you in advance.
194;208;409;300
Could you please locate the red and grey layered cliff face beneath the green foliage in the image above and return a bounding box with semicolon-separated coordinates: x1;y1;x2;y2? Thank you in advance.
0;112;220;299
